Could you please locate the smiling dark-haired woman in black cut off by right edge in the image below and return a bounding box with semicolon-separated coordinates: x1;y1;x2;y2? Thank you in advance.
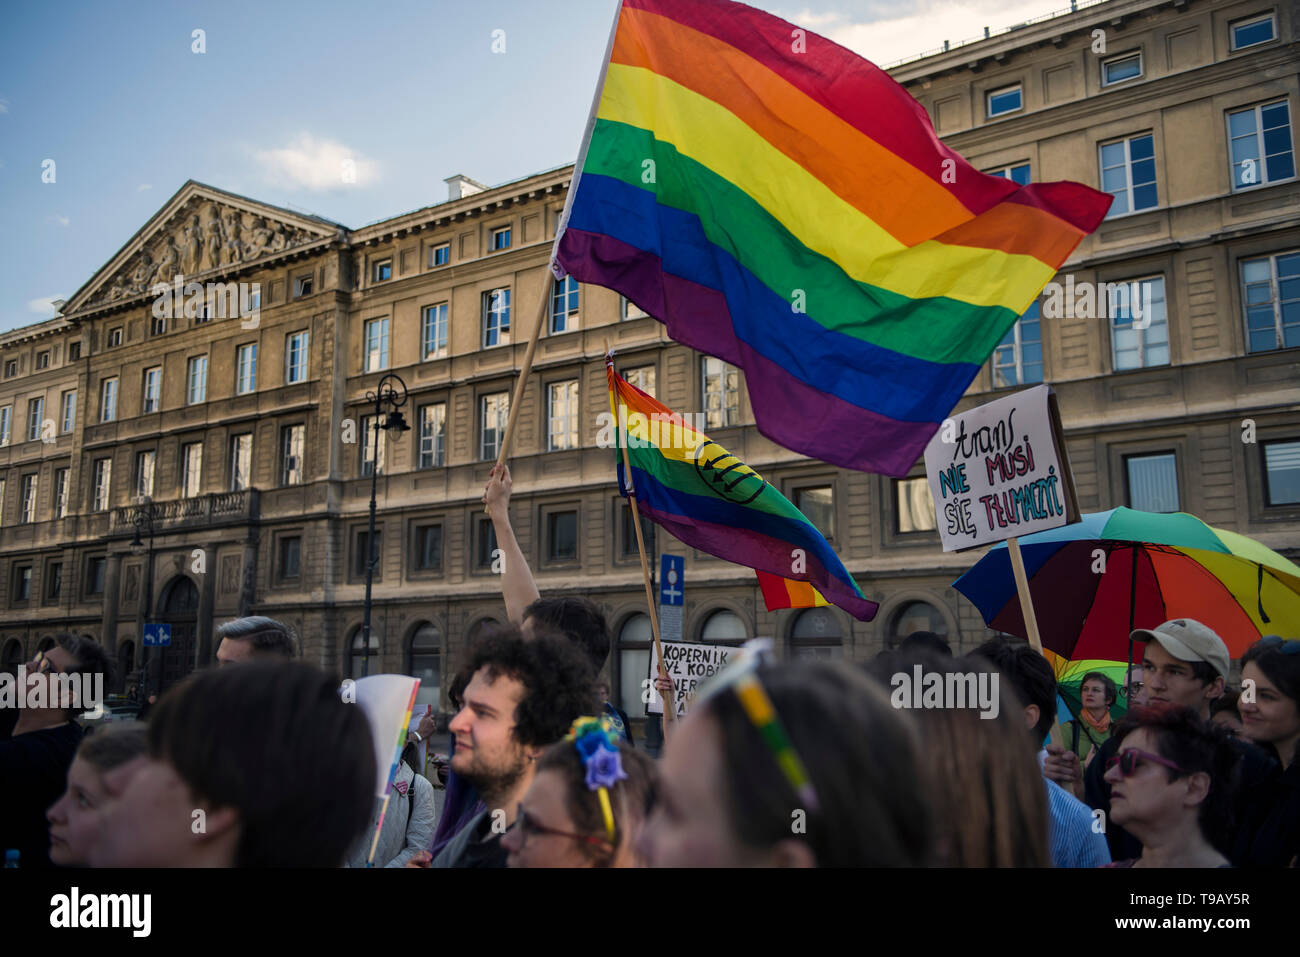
1232;635;1300;867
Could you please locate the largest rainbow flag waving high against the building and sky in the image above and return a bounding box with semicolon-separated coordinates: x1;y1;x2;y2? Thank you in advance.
553;0;1112;476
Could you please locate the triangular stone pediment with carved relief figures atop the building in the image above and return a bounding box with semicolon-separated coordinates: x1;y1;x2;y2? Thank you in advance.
62;181;342;316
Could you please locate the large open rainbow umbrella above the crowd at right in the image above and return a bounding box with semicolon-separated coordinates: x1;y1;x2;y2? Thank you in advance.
953;507;1300;662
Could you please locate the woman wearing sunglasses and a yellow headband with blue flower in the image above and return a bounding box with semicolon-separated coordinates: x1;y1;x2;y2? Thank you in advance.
502;715;658;867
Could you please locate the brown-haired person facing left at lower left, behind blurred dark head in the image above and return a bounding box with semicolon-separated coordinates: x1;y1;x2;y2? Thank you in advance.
46;722;150;867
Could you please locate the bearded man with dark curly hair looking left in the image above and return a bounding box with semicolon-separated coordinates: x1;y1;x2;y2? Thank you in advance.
429;628;597;867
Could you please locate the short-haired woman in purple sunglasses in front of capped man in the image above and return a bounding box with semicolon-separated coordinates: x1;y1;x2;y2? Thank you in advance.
1105;702;1239;867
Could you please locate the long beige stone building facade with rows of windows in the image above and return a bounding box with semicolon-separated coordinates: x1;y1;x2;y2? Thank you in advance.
0;0;1300;715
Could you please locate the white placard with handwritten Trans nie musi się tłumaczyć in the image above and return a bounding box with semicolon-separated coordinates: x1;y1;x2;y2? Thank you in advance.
926;385;1079;551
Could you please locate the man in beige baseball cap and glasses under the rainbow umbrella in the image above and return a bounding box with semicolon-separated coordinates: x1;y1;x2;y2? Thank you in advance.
1076;618;1274;863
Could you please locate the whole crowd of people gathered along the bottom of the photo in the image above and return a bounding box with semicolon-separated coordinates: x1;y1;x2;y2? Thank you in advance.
0;467;1300;869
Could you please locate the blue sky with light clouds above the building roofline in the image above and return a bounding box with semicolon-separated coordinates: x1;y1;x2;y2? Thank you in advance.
0;0;1069;332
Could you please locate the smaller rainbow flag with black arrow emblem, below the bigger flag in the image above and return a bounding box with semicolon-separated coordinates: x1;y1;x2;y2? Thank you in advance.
605;355;878;622
